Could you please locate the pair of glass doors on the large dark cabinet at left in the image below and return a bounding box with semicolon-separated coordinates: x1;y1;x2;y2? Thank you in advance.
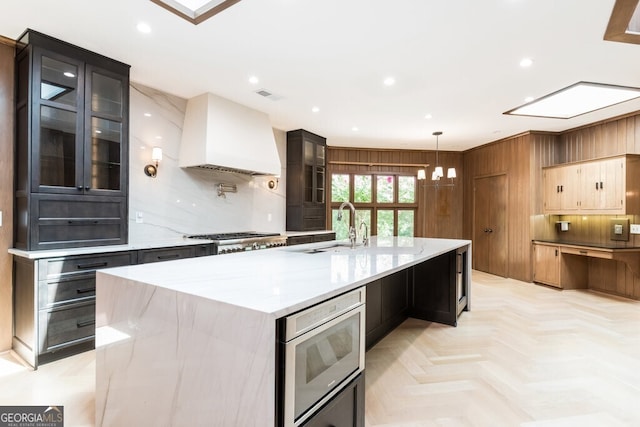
31;48;128;195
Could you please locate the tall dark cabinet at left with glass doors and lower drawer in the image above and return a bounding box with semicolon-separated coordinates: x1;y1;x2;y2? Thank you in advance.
14;30;129;250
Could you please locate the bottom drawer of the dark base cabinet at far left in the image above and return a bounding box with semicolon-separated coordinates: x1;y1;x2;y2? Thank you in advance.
39;303;96;353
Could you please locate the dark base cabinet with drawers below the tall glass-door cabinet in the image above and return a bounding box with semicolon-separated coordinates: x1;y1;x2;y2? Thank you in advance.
13;251;135;368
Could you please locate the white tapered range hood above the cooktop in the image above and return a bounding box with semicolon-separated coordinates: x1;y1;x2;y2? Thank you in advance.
178;93;280;175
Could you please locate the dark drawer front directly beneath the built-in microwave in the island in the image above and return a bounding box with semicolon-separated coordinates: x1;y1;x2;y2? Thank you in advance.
303;372;364;427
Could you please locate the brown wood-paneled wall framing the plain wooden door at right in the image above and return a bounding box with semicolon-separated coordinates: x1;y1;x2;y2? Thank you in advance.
463;133;535;281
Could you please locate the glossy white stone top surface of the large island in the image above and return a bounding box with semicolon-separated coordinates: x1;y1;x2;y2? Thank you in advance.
97;236;471;318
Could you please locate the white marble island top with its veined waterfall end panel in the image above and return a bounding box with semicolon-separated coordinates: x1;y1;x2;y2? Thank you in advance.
96;237;470;426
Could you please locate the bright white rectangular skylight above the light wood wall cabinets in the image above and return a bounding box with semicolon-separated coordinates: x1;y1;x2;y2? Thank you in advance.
504;82;640;119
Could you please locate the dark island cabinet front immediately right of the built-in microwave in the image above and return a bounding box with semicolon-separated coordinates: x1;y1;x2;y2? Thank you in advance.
365;270;409;350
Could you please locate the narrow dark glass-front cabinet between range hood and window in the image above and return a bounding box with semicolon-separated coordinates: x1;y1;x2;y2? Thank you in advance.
286;129;326;231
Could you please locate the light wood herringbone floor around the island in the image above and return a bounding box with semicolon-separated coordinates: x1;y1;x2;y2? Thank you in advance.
0;271;640;427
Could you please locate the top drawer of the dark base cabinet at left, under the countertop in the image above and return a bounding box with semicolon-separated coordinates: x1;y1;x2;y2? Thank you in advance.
38;252;131;280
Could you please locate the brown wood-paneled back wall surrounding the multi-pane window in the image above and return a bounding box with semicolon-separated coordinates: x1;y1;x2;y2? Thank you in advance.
327;146;464;239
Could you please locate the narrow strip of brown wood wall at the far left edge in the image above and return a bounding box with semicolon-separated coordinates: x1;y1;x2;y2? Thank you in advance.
0;38;15;352
